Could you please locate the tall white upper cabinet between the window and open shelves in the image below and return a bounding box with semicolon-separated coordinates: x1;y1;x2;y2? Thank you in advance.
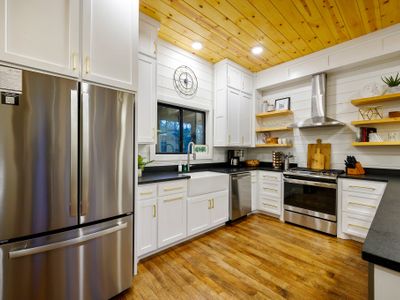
214;60;254;147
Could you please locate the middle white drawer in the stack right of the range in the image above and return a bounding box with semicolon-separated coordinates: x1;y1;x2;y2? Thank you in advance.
342;191;382;217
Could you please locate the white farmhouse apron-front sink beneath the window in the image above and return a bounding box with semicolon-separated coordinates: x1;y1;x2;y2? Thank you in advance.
188;171;229;197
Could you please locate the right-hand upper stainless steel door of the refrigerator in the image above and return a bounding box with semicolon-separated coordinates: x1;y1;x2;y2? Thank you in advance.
80;83;135;223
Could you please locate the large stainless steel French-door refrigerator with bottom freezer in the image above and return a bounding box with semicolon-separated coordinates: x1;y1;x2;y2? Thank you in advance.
0;67;134;299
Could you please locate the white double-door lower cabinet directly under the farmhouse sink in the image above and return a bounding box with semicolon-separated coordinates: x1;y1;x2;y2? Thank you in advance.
187;190;229;236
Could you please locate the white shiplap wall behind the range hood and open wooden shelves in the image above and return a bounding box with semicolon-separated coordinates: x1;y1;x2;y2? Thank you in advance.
248;56;400;169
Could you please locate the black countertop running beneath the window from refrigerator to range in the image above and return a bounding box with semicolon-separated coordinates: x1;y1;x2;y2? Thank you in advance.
138;162;297;185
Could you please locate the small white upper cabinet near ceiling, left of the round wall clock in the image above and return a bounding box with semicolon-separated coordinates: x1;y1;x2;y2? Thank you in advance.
139;13;160;58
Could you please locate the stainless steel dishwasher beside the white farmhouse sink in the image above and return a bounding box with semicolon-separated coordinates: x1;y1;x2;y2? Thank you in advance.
229;172;251;221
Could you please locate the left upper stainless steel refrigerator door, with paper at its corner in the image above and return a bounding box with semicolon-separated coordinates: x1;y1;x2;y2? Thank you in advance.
0;71;78;241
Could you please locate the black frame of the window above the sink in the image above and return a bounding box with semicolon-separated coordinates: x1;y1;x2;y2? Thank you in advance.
155;102;207;155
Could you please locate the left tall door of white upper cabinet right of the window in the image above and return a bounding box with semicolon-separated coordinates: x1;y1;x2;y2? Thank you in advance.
228;89;241;146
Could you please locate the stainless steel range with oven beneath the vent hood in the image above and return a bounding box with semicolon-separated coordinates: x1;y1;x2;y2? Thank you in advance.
283;168;343;235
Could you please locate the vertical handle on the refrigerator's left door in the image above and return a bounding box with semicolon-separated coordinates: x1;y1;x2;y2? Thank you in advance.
70;90;78;217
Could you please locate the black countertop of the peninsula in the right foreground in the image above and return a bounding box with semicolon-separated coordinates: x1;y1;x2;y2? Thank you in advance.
361;170;400;272
